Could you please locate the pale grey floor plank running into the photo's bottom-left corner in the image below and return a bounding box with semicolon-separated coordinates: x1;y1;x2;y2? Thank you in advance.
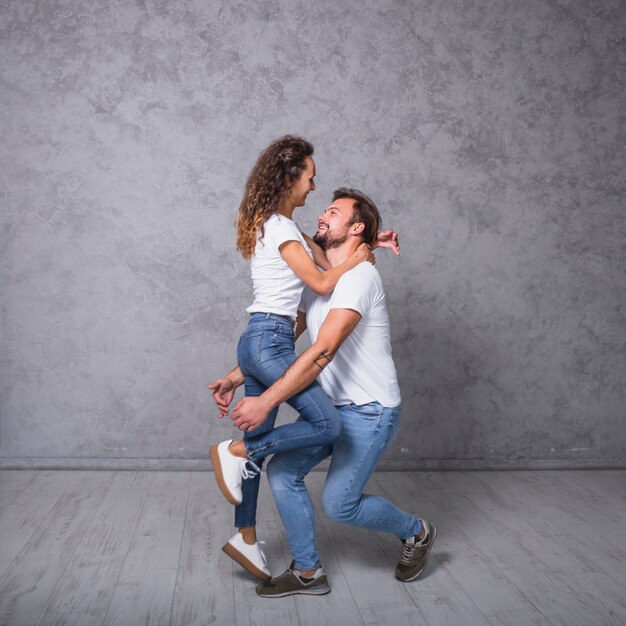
0;472;114;626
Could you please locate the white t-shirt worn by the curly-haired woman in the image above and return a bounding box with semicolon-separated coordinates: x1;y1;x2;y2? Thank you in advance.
246;213;313;320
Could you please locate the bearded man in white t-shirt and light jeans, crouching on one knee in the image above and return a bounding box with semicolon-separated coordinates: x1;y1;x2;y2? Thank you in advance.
224;188;437;597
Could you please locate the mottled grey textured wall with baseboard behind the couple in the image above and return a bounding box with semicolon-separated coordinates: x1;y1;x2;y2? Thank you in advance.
0;0;626;468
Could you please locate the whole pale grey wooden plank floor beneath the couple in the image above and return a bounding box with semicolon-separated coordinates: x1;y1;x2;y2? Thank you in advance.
0;470;626;626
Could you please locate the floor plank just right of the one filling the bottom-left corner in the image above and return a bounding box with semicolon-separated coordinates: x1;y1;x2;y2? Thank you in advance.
39;472;154;626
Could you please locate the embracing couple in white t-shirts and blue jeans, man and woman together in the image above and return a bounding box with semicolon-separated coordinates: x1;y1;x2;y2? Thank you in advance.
209;136;437;598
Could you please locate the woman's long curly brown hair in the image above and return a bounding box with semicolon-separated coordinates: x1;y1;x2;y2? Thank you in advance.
237;135;313;259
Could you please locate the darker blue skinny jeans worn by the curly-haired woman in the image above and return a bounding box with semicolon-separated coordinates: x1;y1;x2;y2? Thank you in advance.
235;313;341;528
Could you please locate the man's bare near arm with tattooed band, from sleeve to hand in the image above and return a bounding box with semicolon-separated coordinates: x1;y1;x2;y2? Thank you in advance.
231;309;361;430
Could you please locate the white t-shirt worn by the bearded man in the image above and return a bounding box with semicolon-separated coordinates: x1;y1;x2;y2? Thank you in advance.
299;263;400;407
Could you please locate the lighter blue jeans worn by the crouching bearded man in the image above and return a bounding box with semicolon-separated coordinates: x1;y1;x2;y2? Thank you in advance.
267;402;421;570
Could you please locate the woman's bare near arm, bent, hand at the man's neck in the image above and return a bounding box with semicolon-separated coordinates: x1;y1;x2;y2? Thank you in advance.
278;239;376;296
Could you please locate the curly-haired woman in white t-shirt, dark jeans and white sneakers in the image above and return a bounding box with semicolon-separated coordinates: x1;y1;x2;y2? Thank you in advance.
209;136;396;580
